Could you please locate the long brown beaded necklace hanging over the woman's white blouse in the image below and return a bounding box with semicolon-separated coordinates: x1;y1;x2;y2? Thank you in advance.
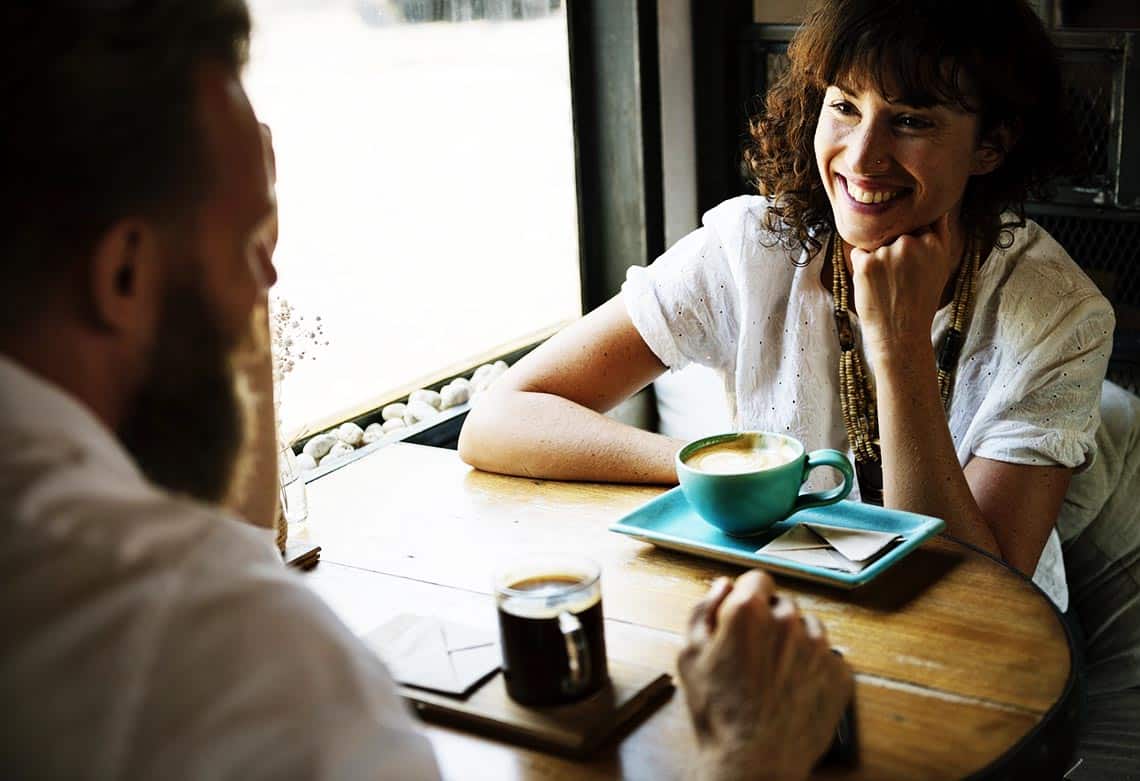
831;234;982;506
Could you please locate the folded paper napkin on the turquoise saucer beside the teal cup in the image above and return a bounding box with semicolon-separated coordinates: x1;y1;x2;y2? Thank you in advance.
757;523;902;575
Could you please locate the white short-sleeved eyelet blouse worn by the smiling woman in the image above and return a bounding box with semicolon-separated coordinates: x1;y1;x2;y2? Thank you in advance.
622;196;1114;610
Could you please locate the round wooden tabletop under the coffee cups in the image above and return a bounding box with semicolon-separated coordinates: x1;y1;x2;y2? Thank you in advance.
296;444;1075;781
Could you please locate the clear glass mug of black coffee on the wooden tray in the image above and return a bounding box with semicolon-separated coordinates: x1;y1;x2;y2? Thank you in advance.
495;554;610;706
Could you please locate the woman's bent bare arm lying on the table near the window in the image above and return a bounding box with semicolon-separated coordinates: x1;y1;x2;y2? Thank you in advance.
459;294;683;485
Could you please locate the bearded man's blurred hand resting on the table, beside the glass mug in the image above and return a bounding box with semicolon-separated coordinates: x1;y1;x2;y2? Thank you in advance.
677;570;854;781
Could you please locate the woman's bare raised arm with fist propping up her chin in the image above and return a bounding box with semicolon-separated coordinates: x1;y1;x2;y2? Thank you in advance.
852;215;1072;576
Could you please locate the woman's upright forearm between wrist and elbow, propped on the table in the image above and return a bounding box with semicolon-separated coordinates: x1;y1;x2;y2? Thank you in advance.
874;341;1001;556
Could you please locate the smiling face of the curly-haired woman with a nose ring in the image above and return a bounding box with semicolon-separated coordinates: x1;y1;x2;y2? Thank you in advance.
815;86;988;250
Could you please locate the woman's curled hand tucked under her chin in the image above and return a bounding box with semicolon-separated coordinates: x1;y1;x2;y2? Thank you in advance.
852;212;958;356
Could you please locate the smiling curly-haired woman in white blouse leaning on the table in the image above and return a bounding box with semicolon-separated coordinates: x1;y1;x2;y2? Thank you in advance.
459;0;1114;610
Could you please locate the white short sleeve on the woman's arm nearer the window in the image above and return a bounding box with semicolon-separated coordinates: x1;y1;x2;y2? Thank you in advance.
621;227;740;372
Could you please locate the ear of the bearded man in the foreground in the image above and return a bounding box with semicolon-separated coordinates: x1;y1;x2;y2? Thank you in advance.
88;219;161;332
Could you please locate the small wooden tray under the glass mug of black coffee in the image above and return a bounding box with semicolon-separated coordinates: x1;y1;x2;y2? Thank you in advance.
399;659;673;758
